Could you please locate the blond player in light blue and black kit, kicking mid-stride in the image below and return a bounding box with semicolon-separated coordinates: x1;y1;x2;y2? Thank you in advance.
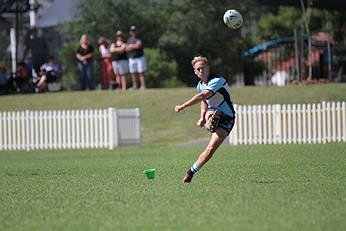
175;56;235;183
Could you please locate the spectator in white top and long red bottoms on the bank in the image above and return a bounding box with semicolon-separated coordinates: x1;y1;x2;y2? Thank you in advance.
98;37;117;89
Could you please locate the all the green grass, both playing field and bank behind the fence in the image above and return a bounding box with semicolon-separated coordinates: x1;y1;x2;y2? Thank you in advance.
0;84;346;231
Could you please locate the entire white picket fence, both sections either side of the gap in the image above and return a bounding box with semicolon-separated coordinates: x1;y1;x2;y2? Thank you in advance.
0;102;346;150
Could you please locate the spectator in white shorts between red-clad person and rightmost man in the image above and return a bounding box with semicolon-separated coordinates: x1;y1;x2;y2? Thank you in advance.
111;30;129;91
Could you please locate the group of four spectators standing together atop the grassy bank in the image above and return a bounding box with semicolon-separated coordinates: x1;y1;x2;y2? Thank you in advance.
76;26;147;91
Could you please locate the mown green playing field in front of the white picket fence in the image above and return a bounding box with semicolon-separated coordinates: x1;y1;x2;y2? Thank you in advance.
0;144;346;231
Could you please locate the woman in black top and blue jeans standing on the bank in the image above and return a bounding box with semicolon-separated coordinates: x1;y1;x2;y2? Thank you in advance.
76;34;95;90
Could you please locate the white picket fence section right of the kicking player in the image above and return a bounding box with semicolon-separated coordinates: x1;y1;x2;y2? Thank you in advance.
229;102;346;145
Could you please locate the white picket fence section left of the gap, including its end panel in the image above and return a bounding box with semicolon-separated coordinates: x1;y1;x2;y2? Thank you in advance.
0;108;141;150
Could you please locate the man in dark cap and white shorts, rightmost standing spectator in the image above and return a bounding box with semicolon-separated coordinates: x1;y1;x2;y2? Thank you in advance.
126;26;147;89
